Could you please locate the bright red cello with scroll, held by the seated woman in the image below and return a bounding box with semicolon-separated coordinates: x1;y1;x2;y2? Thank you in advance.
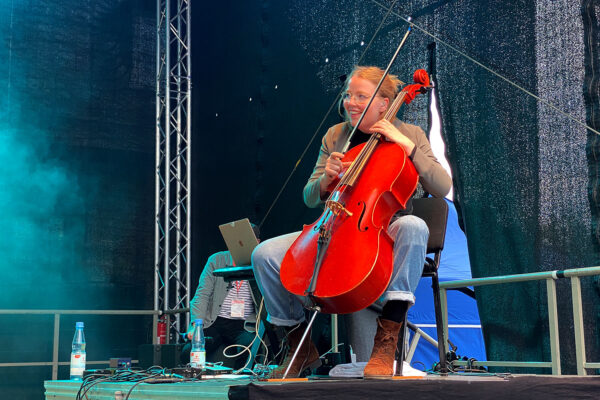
280;69;430;314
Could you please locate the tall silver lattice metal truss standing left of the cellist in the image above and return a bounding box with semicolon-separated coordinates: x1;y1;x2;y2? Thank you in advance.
154;0;192;343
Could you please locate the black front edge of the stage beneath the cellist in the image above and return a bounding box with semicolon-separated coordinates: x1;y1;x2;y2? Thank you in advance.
229;375;600;400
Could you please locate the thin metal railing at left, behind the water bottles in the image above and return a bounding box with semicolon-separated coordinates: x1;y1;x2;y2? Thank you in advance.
0;310;162;380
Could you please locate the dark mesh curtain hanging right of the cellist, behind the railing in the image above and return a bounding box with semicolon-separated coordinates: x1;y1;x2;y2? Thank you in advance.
439;1;598;373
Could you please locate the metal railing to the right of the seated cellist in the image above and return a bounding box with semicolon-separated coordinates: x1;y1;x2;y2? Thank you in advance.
439;267;600;375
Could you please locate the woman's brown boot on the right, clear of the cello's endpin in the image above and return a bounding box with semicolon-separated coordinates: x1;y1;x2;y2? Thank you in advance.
364;318;402;379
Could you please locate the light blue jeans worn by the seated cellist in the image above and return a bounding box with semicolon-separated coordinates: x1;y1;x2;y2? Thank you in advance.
252;215;429;326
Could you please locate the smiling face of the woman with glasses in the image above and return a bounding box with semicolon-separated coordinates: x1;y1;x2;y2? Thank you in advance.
344;76;389;132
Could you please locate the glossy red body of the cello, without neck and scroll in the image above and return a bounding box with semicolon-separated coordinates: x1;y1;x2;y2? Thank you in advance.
281;142;419;314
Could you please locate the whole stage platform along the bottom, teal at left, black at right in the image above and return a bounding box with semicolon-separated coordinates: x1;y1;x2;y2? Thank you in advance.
44;374;600;400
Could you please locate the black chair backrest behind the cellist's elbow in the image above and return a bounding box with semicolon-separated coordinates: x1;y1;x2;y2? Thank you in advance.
413;197;448;253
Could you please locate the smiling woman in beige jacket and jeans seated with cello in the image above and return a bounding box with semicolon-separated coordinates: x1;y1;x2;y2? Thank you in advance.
252;67;452;378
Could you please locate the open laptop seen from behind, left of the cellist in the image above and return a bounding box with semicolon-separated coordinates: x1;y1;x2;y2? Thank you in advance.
219;218;258;266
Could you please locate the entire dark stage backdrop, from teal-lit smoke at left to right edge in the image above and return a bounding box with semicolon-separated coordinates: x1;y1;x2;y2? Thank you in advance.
0;0;599;398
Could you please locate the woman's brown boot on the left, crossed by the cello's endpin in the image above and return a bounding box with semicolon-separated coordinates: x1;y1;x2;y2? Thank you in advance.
271;325;321;379
